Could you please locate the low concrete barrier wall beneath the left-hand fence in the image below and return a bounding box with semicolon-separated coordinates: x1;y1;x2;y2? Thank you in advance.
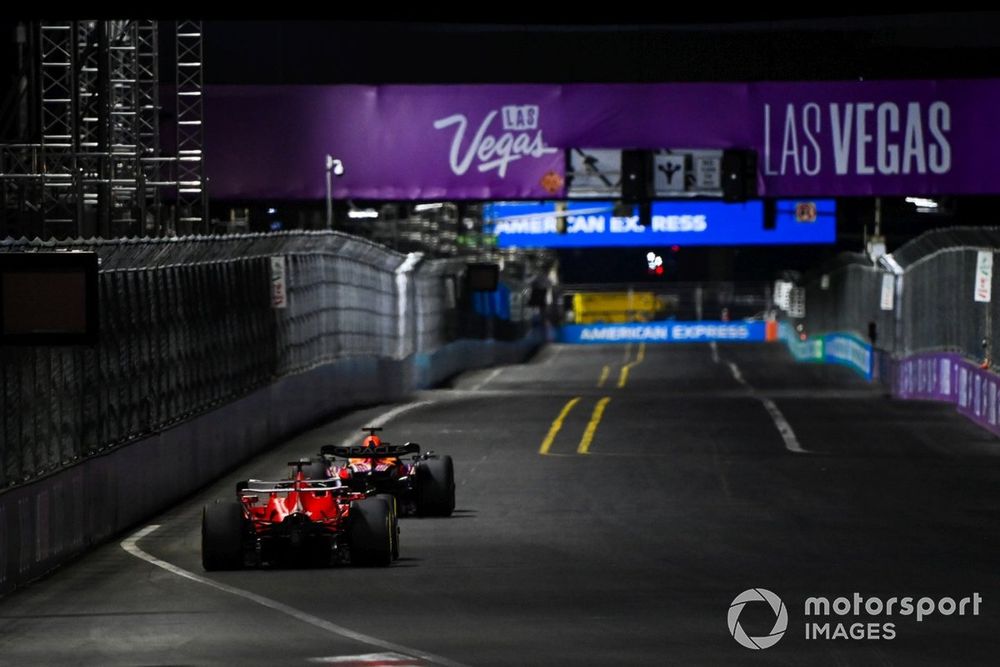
0;332;542;595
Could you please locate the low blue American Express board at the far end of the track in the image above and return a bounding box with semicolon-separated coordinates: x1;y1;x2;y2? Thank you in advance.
559;321;767;343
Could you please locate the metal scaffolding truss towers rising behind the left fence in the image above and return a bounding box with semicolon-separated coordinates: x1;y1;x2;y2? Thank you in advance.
0;20;208;238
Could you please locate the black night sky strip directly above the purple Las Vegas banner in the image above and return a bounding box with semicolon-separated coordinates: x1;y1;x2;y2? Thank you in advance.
199;12;1000;83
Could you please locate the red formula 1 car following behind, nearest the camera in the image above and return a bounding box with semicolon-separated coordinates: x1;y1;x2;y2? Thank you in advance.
201;459;399;570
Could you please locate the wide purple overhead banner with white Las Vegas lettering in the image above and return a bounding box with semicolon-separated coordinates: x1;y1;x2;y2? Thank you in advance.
205;79;1000;200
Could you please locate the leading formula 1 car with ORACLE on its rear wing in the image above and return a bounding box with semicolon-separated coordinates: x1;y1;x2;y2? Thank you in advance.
313;426;455;516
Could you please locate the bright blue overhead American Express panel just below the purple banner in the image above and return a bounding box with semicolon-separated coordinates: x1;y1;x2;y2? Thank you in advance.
483;199;837;248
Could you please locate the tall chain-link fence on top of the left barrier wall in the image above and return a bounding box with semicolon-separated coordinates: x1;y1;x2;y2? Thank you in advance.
0;232;443;486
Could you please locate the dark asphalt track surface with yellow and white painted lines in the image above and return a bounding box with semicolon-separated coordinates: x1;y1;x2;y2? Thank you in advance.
0;344;1000;666
